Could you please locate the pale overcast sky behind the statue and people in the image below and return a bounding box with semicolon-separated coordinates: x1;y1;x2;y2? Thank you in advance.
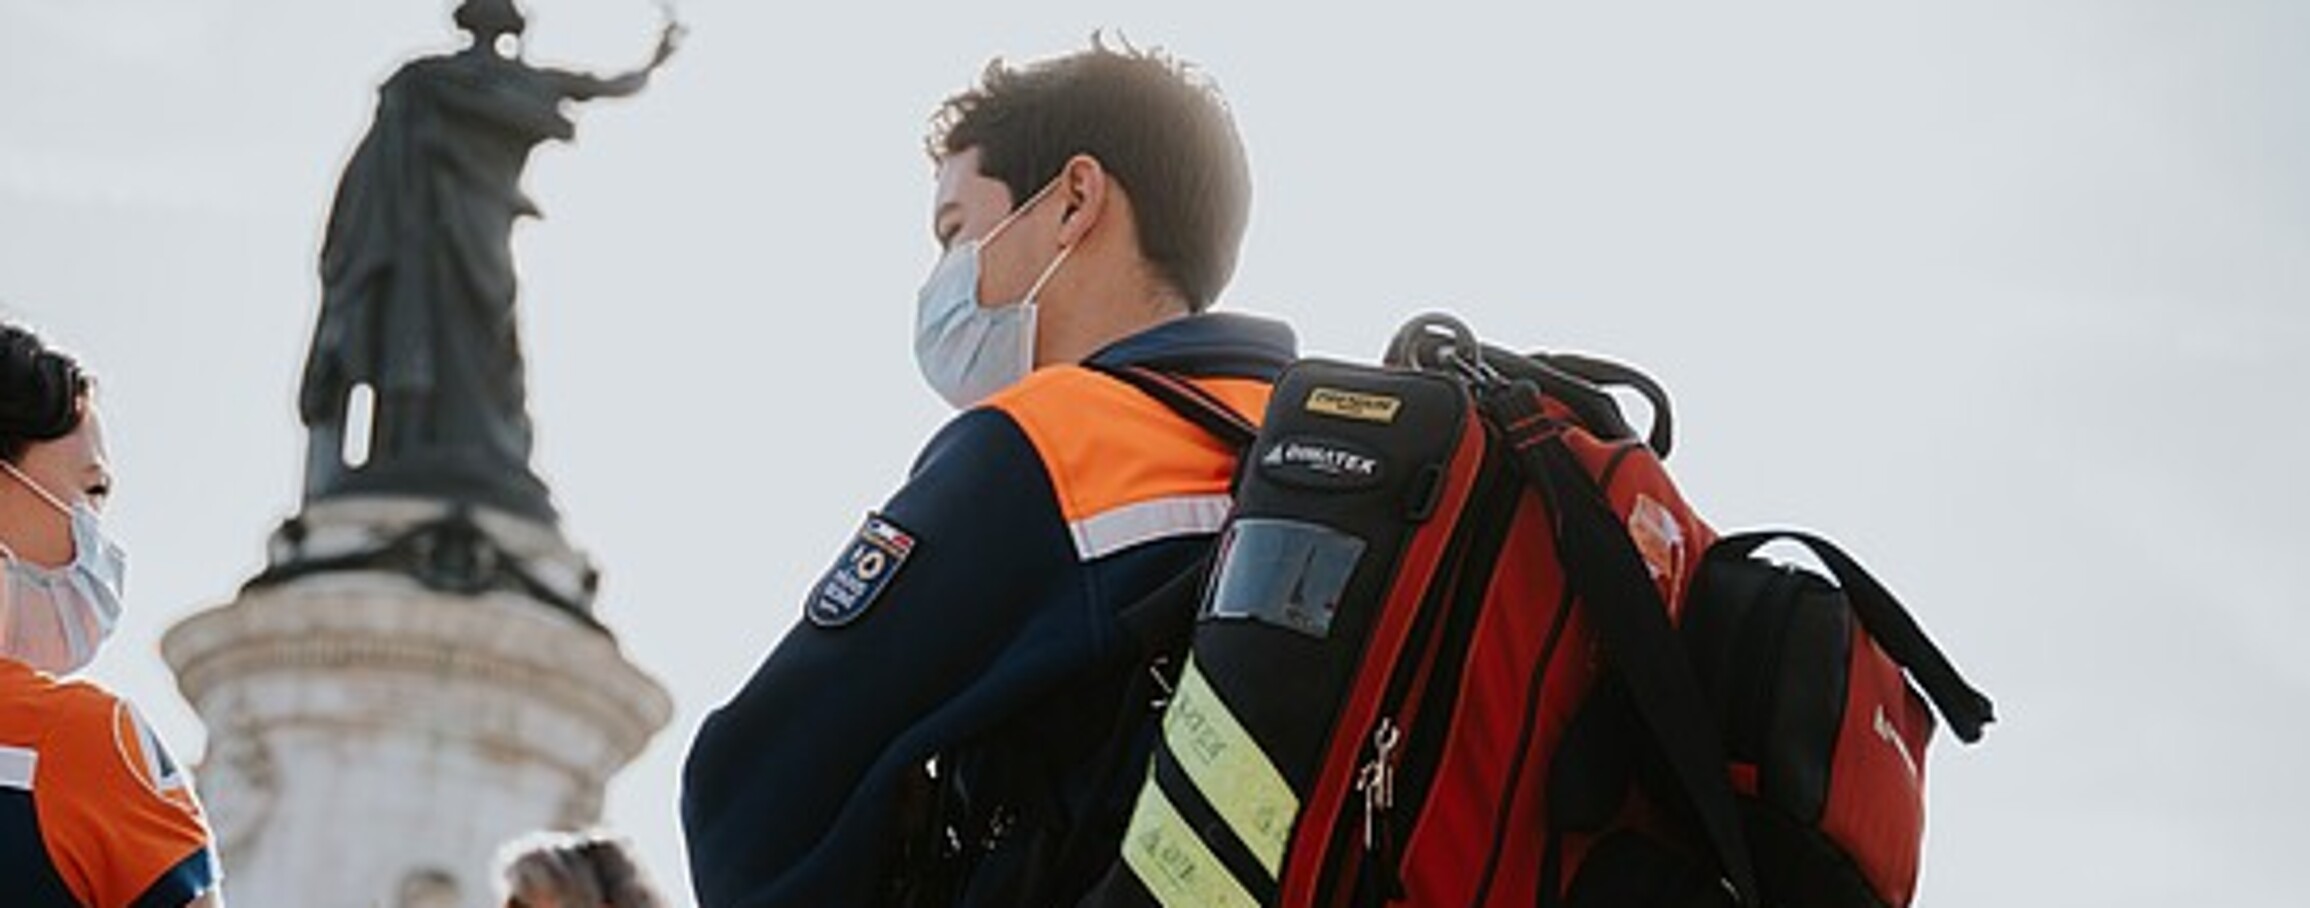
0;0;2310;906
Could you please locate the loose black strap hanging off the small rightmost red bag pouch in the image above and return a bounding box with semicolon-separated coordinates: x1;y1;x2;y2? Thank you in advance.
1716;529;1996;744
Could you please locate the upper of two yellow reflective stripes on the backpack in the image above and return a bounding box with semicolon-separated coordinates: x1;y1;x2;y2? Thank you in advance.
1162;658;1298;878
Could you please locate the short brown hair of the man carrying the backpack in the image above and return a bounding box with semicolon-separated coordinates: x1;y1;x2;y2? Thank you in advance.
929;35;1252;310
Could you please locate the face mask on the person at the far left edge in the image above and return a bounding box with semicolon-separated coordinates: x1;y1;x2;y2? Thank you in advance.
0;460;127;675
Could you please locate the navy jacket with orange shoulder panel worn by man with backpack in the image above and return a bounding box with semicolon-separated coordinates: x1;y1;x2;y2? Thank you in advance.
681;314;1294;908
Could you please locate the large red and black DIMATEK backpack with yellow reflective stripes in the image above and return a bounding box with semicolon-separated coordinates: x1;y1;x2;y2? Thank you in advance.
1083;317;1991;908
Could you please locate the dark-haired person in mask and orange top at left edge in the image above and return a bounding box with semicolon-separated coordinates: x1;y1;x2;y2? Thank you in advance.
0;323;224;908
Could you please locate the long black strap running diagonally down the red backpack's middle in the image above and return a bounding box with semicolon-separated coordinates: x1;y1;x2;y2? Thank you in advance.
1481;379;1763;906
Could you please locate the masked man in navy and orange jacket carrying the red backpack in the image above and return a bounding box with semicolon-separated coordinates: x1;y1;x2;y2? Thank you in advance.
681;39;1296;908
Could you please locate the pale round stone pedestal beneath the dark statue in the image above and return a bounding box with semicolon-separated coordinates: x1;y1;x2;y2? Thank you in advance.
162;499;672;908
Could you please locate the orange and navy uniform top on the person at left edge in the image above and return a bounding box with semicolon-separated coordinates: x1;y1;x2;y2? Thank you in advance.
0;658;219;908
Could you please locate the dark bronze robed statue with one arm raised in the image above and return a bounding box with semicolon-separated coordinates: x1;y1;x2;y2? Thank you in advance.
298;0;681;522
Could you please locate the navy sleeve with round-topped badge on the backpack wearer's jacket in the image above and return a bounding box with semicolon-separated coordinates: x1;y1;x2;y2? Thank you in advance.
681;409;1088;908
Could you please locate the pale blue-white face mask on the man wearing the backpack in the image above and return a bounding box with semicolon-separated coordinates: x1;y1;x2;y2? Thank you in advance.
915;180;1074;409
